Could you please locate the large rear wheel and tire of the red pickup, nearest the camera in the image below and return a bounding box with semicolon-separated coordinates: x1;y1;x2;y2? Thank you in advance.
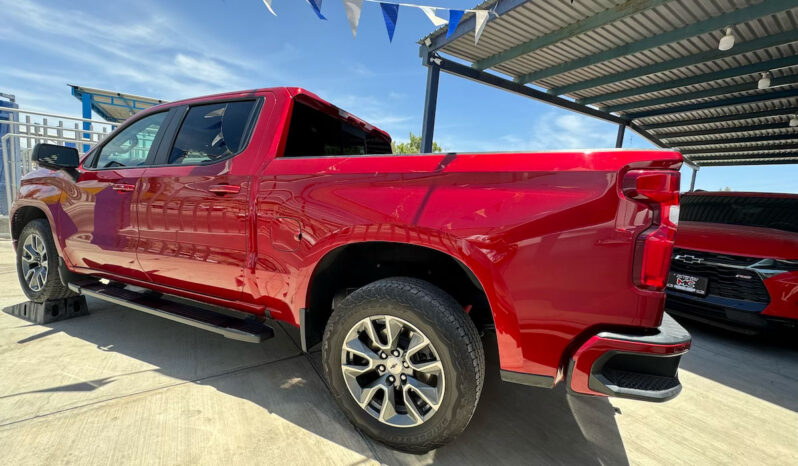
322;278;485;453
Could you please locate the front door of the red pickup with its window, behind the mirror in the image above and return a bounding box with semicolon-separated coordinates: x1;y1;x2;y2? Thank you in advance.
59;111;168;280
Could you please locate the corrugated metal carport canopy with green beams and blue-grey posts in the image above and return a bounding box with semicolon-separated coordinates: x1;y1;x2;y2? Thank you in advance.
419;0;798;166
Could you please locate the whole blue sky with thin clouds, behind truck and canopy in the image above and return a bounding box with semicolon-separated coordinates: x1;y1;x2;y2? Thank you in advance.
0;0;798;192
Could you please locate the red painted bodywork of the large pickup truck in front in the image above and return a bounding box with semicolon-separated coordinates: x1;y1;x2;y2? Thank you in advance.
10;88;682;384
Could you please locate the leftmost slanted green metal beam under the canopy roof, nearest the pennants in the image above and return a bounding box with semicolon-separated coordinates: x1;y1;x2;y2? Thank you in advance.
471;0;670;70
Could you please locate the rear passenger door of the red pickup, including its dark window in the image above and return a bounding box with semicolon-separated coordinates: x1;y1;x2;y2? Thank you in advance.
137;98;263;300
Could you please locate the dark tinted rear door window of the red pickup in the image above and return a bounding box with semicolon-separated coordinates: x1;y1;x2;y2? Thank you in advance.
169;100;255;165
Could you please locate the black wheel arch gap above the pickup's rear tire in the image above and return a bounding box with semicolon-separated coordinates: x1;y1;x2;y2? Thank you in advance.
299;241;493;351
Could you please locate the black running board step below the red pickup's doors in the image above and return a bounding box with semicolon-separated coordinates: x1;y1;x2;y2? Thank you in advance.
69;283;274;343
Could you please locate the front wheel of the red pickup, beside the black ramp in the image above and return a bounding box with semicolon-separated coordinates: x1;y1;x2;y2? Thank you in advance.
17;218;76;303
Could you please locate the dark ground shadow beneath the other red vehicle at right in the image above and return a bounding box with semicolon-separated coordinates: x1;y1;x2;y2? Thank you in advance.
677;317;798;412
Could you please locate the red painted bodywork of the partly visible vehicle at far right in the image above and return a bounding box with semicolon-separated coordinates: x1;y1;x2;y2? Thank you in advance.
676;218;798;319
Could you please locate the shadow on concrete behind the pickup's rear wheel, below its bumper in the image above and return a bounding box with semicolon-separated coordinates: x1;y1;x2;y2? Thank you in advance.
312;333;629;465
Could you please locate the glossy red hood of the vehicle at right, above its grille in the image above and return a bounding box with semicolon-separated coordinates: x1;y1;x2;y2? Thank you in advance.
676;222;798;259
